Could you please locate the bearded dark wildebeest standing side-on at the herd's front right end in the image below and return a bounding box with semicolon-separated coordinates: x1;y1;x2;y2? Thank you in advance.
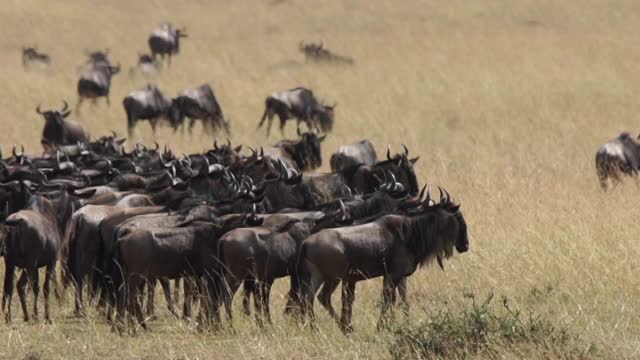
299;187;469;333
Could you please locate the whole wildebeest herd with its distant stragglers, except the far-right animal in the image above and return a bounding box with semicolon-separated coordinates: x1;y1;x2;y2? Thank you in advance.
5;23;469;333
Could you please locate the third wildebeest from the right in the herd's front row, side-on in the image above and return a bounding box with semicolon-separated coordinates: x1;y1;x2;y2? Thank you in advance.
110;214;260;334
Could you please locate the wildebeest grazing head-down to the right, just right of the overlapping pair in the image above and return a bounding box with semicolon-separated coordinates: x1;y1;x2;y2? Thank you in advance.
258;87;335;136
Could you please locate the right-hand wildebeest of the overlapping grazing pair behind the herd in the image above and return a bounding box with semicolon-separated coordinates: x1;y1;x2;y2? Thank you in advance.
171;84;230;135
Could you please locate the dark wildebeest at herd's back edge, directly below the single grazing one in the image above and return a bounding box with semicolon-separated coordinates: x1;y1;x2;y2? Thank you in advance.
265;129;327;171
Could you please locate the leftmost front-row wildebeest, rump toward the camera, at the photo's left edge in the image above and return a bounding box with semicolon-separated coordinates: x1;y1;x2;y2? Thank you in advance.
2;191;91;322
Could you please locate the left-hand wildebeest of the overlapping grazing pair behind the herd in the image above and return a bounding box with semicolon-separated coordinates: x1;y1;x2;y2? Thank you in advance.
122;84;172;138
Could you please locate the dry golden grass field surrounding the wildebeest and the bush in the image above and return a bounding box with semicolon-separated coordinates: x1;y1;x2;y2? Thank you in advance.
0;0;640;359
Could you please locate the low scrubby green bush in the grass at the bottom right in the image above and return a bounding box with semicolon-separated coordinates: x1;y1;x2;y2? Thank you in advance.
389;294;595;359
